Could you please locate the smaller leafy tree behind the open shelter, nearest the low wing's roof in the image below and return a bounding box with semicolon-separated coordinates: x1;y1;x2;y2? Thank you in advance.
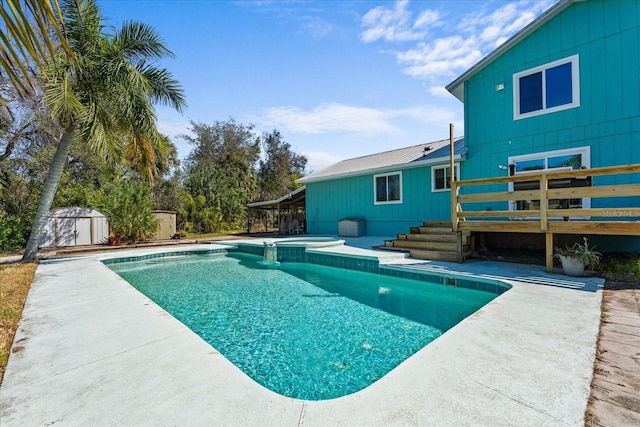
258;129;307;200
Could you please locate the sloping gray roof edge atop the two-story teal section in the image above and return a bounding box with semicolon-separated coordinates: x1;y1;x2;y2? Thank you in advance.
446;0;585;102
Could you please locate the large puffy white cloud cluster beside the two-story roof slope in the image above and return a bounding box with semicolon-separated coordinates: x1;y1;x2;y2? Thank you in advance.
360;0;555;86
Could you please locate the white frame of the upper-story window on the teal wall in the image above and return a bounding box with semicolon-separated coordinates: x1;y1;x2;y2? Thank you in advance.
513;54;580;120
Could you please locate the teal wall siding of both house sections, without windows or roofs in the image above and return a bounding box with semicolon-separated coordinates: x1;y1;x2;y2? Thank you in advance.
307;0;640;247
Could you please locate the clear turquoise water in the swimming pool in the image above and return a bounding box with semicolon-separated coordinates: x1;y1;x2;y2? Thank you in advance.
109;253;497;400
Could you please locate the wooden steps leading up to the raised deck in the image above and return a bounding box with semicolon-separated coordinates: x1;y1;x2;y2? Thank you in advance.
379;221;473;262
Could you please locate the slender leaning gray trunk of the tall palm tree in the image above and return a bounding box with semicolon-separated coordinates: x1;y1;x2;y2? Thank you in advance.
22;126;76;261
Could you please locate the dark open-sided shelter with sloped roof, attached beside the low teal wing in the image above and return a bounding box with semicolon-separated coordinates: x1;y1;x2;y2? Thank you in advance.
247;185;307;235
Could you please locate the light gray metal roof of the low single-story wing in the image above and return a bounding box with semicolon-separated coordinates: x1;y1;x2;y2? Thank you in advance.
297;137;466;183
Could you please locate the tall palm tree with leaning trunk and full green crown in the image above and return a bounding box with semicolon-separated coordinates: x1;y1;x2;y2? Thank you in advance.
10;0;186;261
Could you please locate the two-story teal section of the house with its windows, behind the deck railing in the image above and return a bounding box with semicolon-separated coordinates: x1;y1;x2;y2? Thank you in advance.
447;0;640;210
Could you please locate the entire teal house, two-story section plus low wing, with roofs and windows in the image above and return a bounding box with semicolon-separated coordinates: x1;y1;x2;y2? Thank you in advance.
299;0;640;251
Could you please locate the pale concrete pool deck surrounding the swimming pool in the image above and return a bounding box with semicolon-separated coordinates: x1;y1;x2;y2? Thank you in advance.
0;245;604;426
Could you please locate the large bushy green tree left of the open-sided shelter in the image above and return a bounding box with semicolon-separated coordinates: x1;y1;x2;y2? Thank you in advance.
184;119;260;228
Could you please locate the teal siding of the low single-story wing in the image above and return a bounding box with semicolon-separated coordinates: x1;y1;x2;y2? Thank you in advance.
306;166;451;237
